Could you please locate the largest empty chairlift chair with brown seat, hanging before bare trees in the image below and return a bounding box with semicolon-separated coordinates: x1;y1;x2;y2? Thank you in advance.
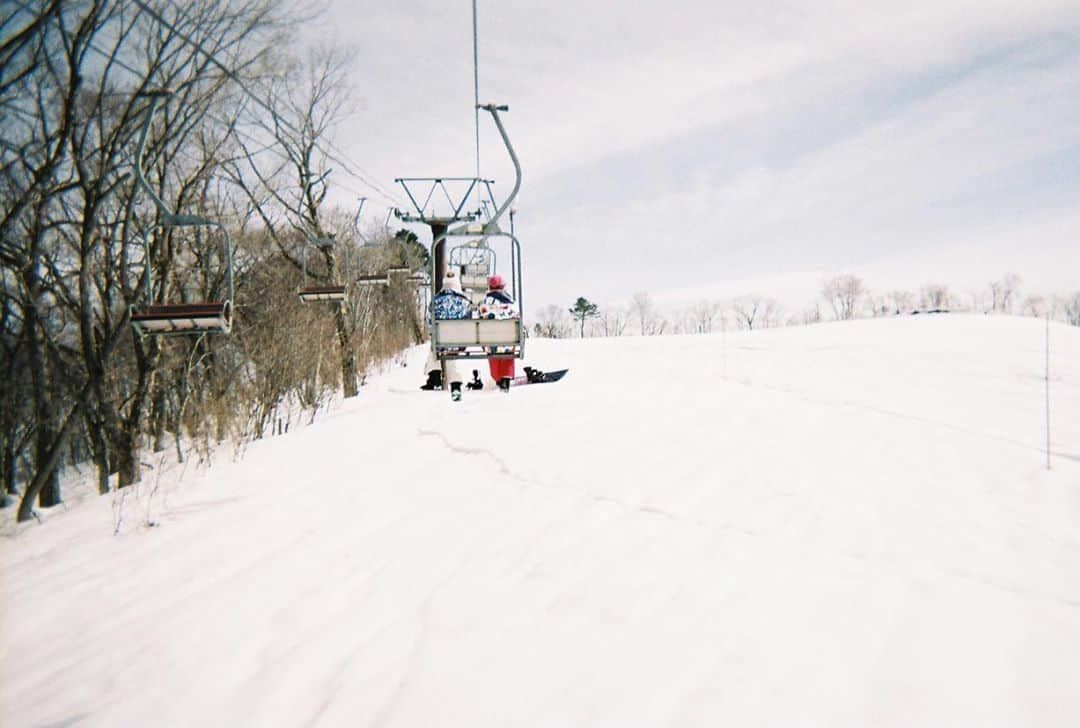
130;89;233;336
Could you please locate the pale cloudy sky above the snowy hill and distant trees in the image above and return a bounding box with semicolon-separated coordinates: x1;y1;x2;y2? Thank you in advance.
304;0;1080;311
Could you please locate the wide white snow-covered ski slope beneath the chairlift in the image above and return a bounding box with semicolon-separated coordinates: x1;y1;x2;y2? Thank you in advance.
0;315;1080;728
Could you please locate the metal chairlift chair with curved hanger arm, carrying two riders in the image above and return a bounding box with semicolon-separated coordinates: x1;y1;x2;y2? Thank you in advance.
431;104;525;360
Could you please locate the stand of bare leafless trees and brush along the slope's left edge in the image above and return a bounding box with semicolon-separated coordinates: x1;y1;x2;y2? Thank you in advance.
0;0;427;520
